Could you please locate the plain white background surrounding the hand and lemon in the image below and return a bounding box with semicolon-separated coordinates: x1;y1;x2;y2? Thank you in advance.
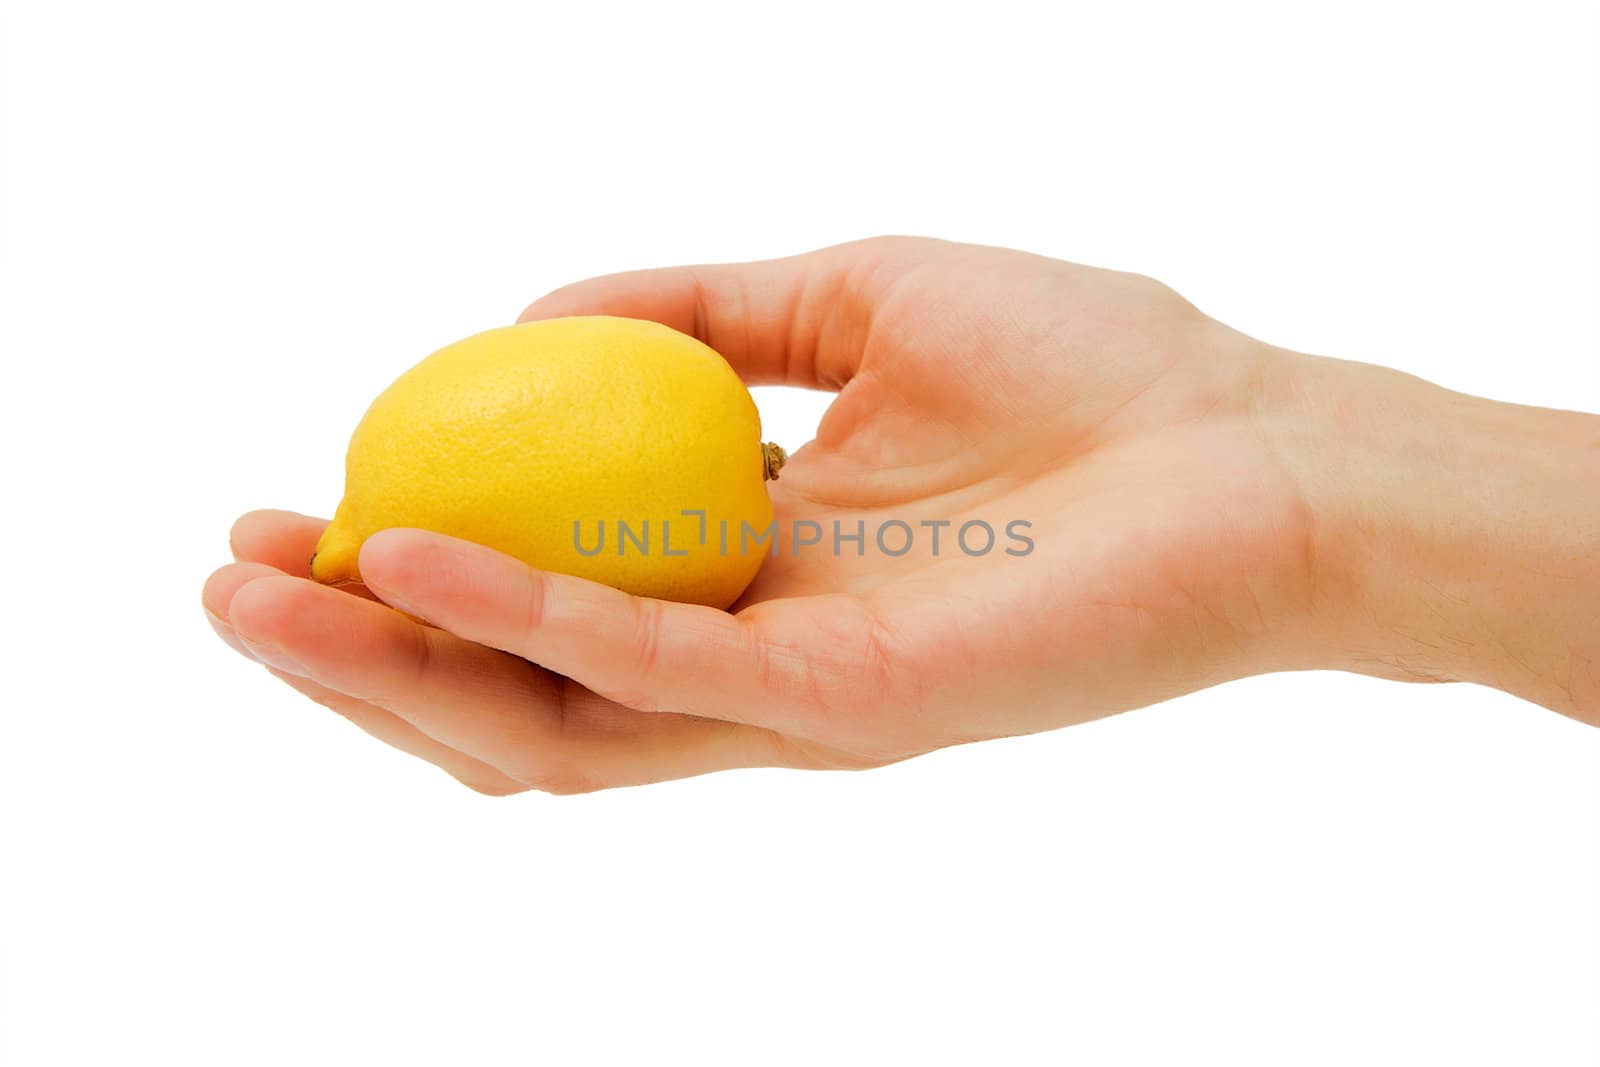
0;2;1600;1067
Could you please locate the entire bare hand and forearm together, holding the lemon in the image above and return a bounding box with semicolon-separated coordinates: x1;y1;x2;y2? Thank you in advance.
203;237;1600;795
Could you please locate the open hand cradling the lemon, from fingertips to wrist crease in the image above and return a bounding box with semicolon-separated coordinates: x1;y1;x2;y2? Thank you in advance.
203;238;1314;793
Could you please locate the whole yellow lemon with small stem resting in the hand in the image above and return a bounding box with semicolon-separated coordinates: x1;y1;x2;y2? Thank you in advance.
310;315;782;608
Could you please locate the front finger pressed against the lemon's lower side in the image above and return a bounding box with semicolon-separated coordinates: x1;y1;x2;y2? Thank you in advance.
360;530;872;737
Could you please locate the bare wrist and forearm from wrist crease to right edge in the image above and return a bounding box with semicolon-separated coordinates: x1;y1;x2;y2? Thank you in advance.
1269;352;1600;725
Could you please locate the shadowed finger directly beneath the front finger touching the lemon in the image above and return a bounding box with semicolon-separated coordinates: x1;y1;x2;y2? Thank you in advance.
211;574;789;793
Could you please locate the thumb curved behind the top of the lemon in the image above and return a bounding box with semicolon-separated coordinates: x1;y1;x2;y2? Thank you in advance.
518;237;952;389
